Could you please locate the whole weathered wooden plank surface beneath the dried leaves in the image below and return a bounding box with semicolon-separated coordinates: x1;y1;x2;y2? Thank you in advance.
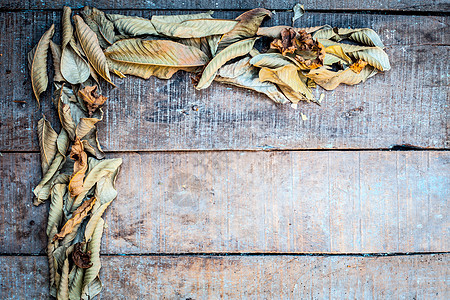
0;0;450;299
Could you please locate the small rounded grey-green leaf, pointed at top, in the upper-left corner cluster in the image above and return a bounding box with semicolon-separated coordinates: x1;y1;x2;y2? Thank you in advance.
61;44;90;84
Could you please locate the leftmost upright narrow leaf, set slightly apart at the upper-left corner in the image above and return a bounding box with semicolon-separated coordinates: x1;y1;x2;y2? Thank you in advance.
28;24;55;104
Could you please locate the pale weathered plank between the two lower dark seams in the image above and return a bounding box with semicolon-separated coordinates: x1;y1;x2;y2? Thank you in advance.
0;151;450;254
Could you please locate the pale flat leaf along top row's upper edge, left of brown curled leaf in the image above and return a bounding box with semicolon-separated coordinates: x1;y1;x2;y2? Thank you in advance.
152;19;238;38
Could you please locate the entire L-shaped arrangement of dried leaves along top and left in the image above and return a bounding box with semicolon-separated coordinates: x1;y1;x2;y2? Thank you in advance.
28;5;390;299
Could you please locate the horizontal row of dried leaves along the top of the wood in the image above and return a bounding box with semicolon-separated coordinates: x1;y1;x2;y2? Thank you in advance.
30;7;390;108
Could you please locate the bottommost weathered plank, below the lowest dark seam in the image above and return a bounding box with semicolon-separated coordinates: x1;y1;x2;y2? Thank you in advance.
0;254;450;299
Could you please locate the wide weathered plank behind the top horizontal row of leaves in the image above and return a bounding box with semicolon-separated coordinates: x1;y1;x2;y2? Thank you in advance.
0;11;450;151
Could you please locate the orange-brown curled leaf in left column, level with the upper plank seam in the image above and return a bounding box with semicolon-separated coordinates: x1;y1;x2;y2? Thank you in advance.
69;138;88;197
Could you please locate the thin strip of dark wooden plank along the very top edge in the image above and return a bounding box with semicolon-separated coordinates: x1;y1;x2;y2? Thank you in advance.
0;0;450;12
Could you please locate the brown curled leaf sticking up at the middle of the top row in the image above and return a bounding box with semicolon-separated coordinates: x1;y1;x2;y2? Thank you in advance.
217;8;272;53
